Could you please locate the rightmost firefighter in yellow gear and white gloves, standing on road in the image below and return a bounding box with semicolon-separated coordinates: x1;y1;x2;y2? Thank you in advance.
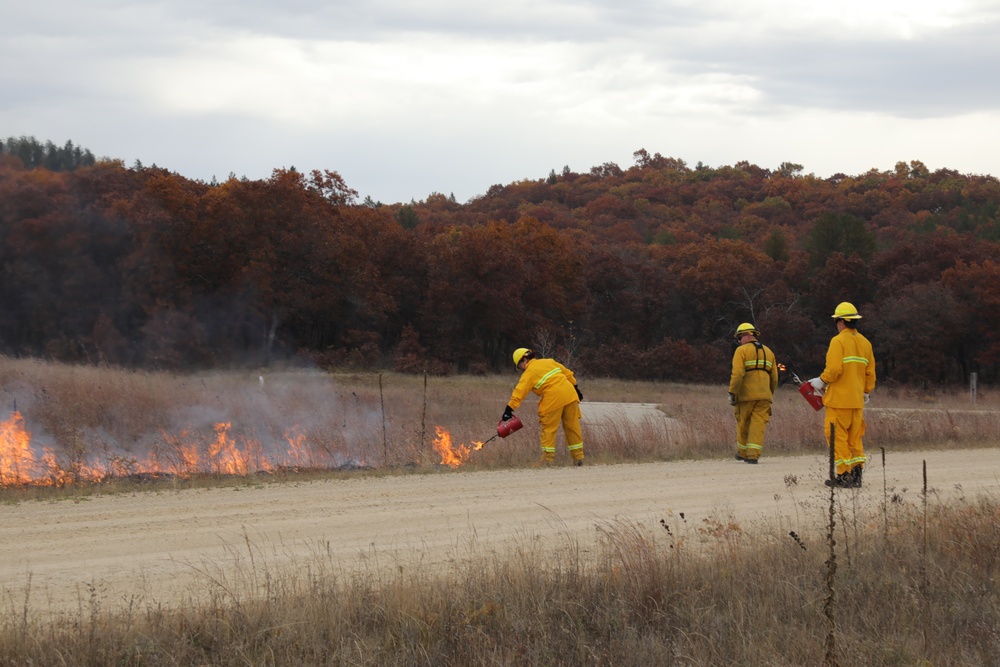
809;301;875;488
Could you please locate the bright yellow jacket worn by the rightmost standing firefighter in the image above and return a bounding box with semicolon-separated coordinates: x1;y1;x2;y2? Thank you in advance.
819;329;875;408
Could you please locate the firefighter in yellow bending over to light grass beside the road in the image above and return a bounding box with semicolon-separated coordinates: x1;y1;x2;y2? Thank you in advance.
501;347;583;466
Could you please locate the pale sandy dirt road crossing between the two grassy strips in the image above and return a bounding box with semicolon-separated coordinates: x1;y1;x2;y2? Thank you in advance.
0;449;1000;615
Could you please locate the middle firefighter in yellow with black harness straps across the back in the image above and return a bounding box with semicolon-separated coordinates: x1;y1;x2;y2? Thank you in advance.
729;322;778;463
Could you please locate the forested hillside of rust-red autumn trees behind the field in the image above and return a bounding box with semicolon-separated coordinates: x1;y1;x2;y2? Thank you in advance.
0;145;1000;385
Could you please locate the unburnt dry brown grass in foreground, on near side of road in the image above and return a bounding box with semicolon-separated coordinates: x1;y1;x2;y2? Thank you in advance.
0;496;1000;667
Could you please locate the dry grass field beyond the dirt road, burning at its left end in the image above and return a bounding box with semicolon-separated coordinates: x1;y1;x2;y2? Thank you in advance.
0;357;1000;494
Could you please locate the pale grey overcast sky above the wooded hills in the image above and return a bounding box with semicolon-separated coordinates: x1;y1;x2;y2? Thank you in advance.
0;0;1000;203
